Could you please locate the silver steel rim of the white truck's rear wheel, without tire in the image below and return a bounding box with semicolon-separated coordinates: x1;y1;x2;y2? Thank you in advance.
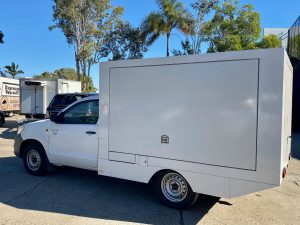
161;173;188;202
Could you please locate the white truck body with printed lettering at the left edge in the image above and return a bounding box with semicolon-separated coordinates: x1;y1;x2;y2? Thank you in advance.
0;77;20;116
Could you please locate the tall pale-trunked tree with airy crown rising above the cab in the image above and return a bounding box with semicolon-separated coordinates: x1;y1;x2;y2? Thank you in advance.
49;0;123;81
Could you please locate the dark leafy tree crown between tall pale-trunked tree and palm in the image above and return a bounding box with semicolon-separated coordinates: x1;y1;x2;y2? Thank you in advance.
101;20;147;60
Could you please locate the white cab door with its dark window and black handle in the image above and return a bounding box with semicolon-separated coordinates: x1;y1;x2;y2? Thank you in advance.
49;99;99;170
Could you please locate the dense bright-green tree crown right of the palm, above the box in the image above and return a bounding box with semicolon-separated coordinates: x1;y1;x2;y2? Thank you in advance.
203;0;260;52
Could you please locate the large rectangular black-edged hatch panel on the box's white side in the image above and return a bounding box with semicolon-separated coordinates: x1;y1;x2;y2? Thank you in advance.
109;59;258;170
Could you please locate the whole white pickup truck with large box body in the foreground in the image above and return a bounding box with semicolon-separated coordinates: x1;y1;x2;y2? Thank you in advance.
15;49;293;208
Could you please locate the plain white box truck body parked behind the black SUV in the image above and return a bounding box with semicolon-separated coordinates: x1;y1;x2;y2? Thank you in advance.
20;78;81;118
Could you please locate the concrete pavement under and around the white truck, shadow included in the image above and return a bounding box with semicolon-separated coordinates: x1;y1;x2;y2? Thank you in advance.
0;117;300;225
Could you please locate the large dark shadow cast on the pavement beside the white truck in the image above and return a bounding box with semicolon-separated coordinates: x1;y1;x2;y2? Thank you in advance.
0;157;219;225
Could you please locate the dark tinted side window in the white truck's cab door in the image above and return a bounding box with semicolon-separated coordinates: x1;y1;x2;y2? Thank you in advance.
62;100;99;124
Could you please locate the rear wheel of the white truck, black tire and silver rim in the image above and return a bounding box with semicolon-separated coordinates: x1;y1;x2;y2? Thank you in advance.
154;171;199;209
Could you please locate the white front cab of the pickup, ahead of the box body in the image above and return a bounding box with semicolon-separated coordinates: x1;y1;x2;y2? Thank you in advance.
15;96;99;171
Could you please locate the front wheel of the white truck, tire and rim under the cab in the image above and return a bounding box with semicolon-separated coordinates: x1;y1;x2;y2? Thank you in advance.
23;143;48;176
